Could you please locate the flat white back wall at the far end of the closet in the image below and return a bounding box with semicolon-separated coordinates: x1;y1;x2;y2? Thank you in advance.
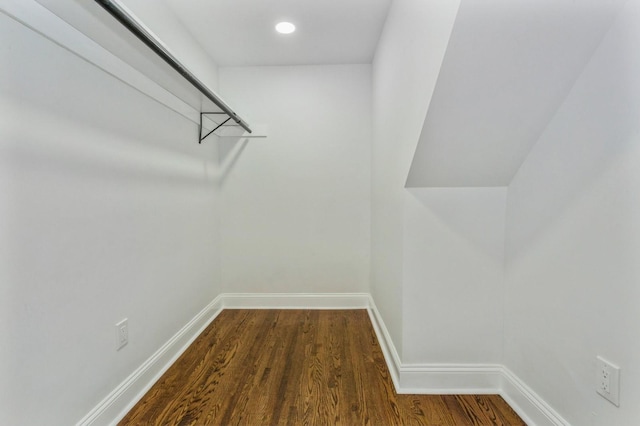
219;65;371;293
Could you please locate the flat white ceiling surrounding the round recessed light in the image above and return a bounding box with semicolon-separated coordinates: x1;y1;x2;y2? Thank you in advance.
165;0;391;66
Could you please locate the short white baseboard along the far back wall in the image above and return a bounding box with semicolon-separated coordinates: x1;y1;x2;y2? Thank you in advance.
223;293;371;309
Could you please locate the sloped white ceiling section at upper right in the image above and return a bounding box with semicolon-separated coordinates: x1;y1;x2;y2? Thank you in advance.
406;0;624;187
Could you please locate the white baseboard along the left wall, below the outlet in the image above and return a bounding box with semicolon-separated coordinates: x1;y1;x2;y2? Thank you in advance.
78;296;223;426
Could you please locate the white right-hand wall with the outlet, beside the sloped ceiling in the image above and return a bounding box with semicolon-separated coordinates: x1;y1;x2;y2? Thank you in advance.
504;0;640;426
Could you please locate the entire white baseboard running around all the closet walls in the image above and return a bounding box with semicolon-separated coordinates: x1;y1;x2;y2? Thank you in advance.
78;293;569;426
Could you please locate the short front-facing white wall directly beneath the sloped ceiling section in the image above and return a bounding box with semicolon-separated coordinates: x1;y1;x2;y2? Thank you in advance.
402;188;507;364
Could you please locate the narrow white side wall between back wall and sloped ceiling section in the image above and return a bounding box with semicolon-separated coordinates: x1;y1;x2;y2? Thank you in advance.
371;0;459;360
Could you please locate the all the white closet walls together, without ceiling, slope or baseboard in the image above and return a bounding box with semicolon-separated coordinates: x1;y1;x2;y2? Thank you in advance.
10;0;640;425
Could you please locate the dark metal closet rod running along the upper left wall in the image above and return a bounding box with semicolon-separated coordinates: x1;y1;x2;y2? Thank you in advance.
95;0;251;133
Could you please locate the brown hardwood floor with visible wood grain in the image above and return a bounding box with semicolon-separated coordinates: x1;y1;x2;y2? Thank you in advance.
120;310;524;426
